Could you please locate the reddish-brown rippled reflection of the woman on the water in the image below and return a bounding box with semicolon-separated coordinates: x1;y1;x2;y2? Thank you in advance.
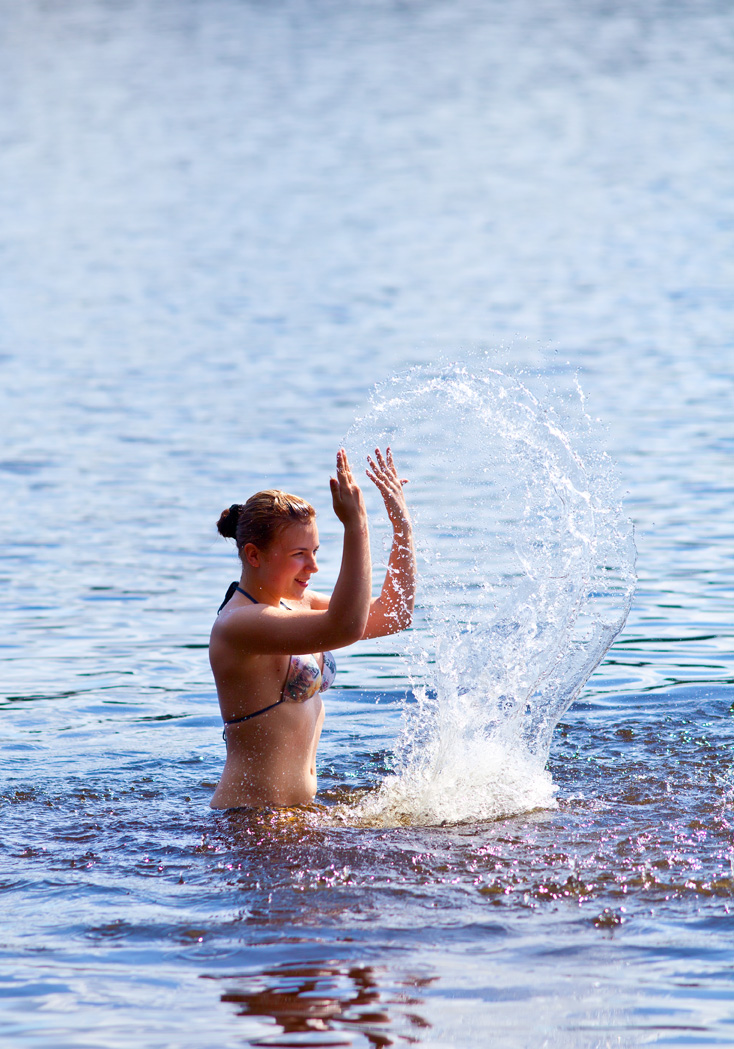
209;962;432;1049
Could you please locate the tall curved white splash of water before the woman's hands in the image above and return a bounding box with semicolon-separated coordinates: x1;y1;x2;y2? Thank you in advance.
345;364;635;826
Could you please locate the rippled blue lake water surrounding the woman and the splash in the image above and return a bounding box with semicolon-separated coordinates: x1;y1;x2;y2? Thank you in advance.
0;0;734;1049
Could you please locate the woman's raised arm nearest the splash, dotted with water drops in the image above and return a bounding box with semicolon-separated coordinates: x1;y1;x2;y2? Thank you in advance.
363;448;415;638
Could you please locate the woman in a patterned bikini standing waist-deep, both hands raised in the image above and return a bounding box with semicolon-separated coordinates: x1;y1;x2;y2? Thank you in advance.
209;448;415;809
